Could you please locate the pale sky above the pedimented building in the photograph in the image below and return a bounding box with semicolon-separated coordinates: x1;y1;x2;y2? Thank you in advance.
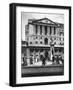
21;12;64;40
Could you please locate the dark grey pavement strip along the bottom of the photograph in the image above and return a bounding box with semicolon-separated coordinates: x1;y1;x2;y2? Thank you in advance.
21;65;64;77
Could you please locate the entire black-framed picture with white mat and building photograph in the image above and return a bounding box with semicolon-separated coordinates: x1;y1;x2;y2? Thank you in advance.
10;3;71;86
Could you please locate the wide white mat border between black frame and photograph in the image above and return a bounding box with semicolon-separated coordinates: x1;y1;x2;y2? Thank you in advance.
16;6;69;84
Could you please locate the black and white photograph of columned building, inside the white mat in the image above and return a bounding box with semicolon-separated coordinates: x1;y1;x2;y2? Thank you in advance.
21;12;64;77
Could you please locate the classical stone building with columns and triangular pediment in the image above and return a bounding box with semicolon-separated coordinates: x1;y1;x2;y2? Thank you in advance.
22;18;64;65
